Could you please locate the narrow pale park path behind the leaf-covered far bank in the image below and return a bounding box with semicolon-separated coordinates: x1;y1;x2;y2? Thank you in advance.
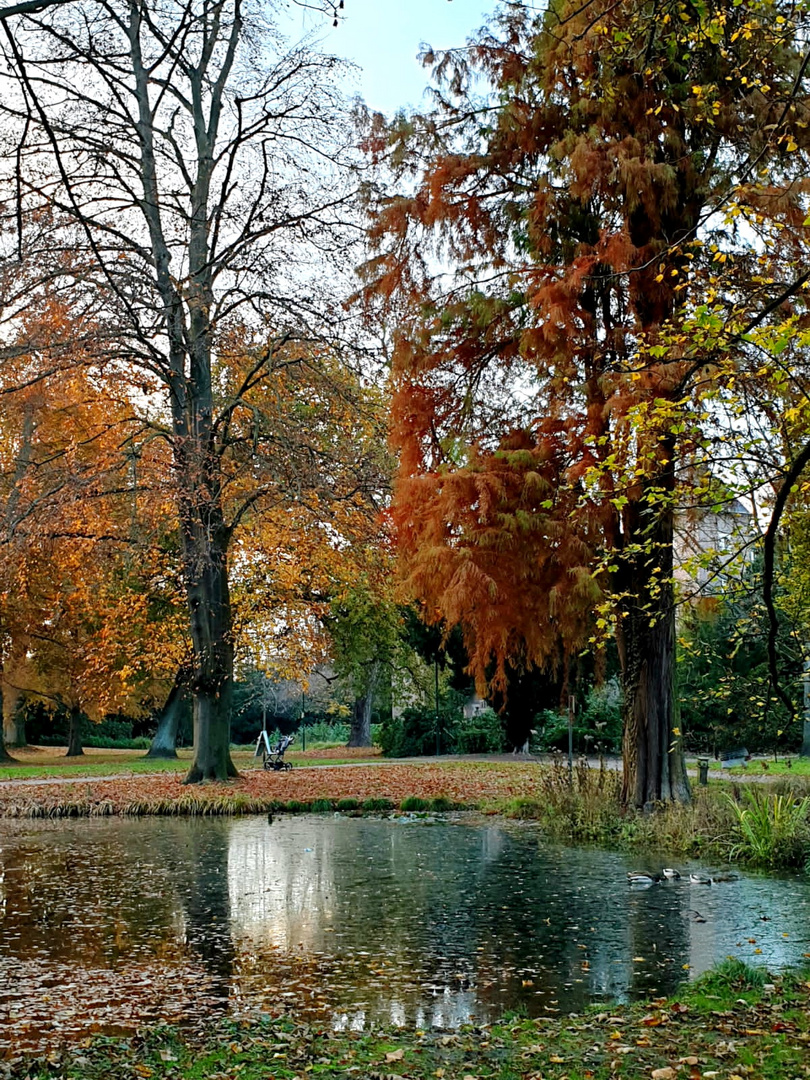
0;754;784;788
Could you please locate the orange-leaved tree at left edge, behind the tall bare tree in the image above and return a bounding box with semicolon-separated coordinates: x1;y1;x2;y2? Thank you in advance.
0;301;187;754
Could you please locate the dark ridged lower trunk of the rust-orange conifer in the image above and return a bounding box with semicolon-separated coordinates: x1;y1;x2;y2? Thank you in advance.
619;460;690;809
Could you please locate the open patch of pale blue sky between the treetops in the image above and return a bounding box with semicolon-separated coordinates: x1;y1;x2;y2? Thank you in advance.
289;0;496;114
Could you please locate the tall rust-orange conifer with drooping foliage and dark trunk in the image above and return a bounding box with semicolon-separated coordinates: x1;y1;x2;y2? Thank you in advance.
365;0;807;806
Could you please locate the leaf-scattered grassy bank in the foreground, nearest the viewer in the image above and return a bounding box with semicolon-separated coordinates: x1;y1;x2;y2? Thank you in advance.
9;961;810;1080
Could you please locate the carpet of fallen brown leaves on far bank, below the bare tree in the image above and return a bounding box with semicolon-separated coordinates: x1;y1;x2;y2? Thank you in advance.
0;761;546;816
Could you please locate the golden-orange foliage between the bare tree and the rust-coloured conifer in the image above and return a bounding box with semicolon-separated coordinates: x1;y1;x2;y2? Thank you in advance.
224;335;391;704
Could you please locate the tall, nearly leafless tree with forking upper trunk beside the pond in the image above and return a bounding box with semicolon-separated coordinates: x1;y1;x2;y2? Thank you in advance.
0;0;354;782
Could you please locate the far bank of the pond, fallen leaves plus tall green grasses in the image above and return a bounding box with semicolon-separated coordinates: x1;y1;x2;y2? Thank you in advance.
0;759;810;868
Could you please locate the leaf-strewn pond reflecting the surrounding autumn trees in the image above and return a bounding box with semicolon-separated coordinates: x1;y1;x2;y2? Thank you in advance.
0;816;810;1047
